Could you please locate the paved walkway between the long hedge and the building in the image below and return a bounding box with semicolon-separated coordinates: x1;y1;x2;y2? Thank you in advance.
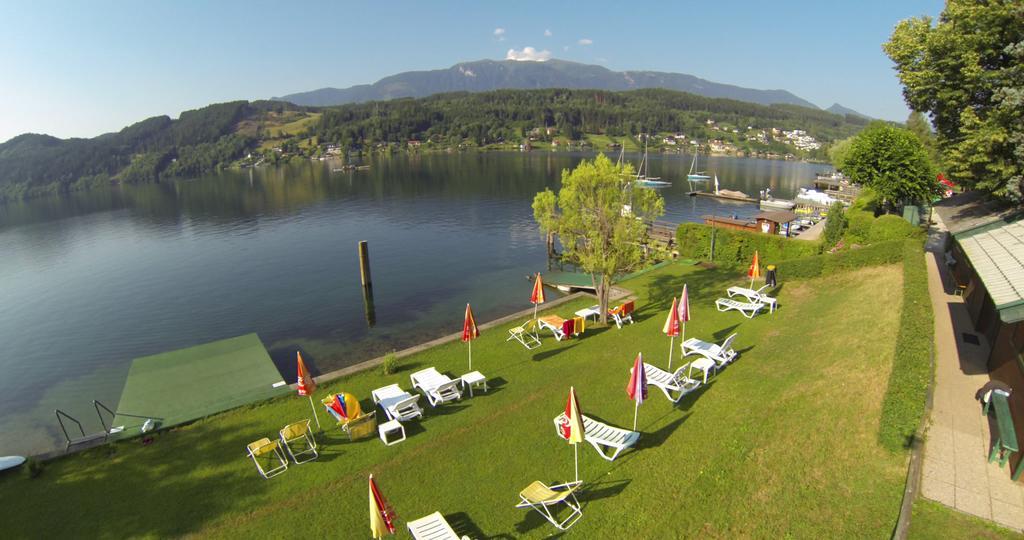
921;216;1024;530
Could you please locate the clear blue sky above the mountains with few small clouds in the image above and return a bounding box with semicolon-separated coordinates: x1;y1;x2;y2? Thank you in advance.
0;0;942;140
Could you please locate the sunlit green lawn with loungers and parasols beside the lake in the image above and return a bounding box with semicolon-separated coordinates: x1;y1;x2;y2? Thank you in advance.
0;264;906;538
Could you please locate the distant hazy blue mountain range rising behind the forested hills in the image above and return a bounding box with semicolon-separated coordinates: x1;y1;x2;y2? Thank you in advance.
273;59;831;111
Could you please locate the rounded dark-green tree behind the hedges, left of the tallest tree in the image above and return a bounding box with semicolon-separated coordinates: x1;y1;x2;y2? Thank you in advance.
839;122;938;208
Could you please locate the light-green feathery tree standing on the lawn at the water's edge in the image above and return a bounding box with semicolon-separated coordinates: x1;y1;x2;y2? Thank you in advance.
534;154;665;323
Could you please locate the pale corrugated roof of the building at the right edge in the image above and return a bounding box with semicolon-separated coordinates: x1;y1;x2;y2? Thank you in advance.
959;221;1024;309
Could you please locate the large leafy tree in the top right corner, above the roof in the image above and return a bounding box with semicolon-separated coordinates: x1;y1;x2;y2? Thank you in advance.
884;0;1024;203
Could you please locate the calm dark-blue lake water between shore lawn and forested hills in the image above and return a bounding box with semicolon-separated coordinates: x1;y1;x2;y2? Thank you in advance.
0;153;825;455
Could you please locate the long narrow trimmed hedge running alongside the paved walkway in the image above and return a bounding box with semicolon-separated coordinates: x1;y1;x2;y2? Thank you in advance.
879;240;935;452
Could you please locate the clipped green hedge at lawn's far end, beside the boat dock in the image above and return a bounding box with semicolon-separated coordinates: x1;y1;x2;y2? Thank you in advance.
676;223;821;266
